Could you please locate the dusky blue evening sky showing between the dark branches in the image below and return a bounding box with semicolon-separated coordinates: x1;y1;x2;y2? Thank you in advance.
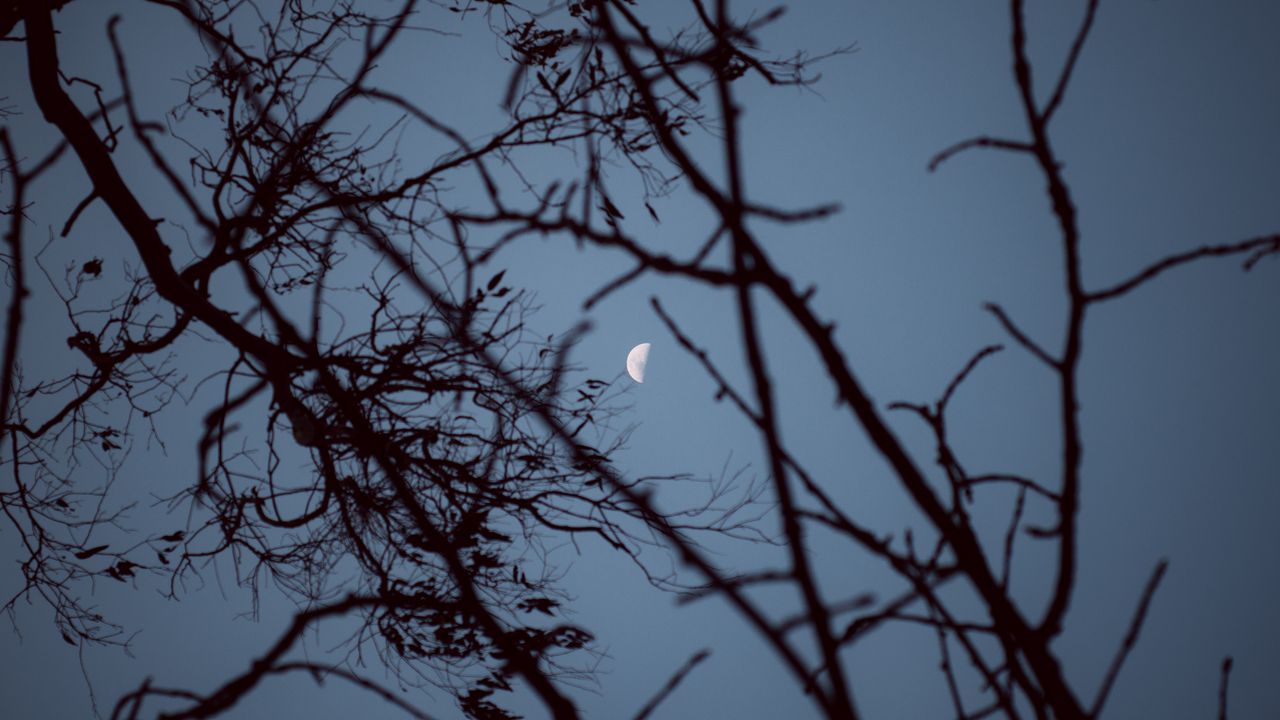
0;0;1280;720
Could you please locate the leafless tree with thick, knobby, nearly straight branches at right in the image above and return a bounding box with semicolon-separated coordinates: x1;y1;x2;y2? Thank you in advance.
517;0;1280;719
